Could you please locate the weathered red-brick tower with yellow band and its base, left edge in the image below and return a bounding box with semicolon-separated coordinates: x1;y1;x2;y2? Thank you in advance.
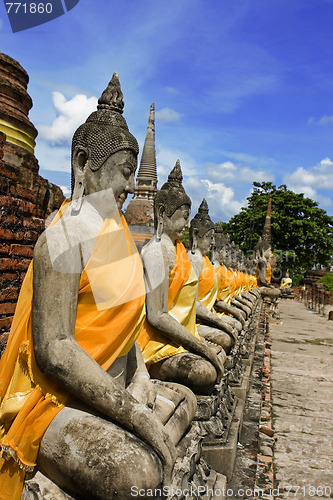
0;53;64;348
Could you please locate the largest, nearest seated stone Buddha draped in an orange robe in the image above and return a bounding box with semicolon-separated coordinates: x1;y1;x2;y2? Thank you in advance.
0;73;196;500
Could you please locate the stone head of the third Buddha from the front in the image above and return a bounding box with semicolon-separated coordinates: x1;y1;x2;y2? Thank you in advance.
190;198;215;256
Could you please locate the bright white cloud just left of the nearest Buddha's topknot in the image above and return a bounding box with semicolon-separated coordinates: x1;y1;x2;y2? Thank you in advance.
38;92;97;144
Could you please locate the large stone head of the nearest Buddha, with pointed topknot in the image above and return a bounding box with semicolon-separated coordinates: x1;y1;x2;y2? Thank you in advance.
71;73;139;212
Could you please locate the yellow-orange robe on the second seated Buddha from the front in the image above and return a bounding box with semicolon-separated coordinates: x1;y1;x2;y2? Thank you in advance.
138;241;200;367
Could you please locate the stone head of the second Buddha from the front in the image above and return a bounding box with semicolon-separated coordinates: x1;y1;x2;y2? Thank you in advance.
154;160;191;243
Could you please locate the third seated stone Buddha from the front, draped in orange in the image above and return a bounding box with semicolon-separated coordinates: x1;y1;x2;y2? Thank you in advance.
188;198;238;352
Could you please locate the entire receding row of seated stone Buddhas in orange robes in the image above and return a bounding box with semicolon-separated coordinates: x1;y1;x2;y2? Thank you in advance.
0;73;270;500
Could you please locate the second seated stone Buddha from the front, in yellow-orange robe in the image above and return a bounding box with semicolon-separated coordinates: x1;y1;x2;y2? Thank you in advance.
139;161;226;394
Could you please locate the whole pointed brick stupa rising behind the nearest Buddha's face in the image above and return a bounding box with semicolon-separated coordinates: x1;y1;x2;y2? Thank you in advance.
126;104;157;237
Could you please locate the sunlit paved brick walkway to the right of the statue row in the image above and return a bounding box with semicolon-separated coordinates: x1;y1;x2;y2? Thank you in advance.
270;300;333;500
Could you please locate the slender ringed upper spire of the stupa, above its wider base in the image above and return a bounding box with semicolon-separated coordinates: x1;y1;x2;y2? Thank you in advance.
137;104;157;188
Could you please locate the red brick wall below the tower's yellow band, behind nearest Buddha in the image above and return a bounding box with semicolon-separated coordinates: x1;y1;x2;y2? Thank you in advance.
0;132;64;354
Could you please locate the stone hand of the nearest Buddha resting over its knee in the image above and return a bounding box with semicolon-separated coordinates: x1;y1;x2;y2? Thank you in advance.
132;404;177;486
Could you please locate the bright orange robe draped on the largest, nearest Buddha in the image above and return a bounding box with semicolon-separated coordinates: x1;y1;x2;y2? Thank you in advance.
0;201;145;500
